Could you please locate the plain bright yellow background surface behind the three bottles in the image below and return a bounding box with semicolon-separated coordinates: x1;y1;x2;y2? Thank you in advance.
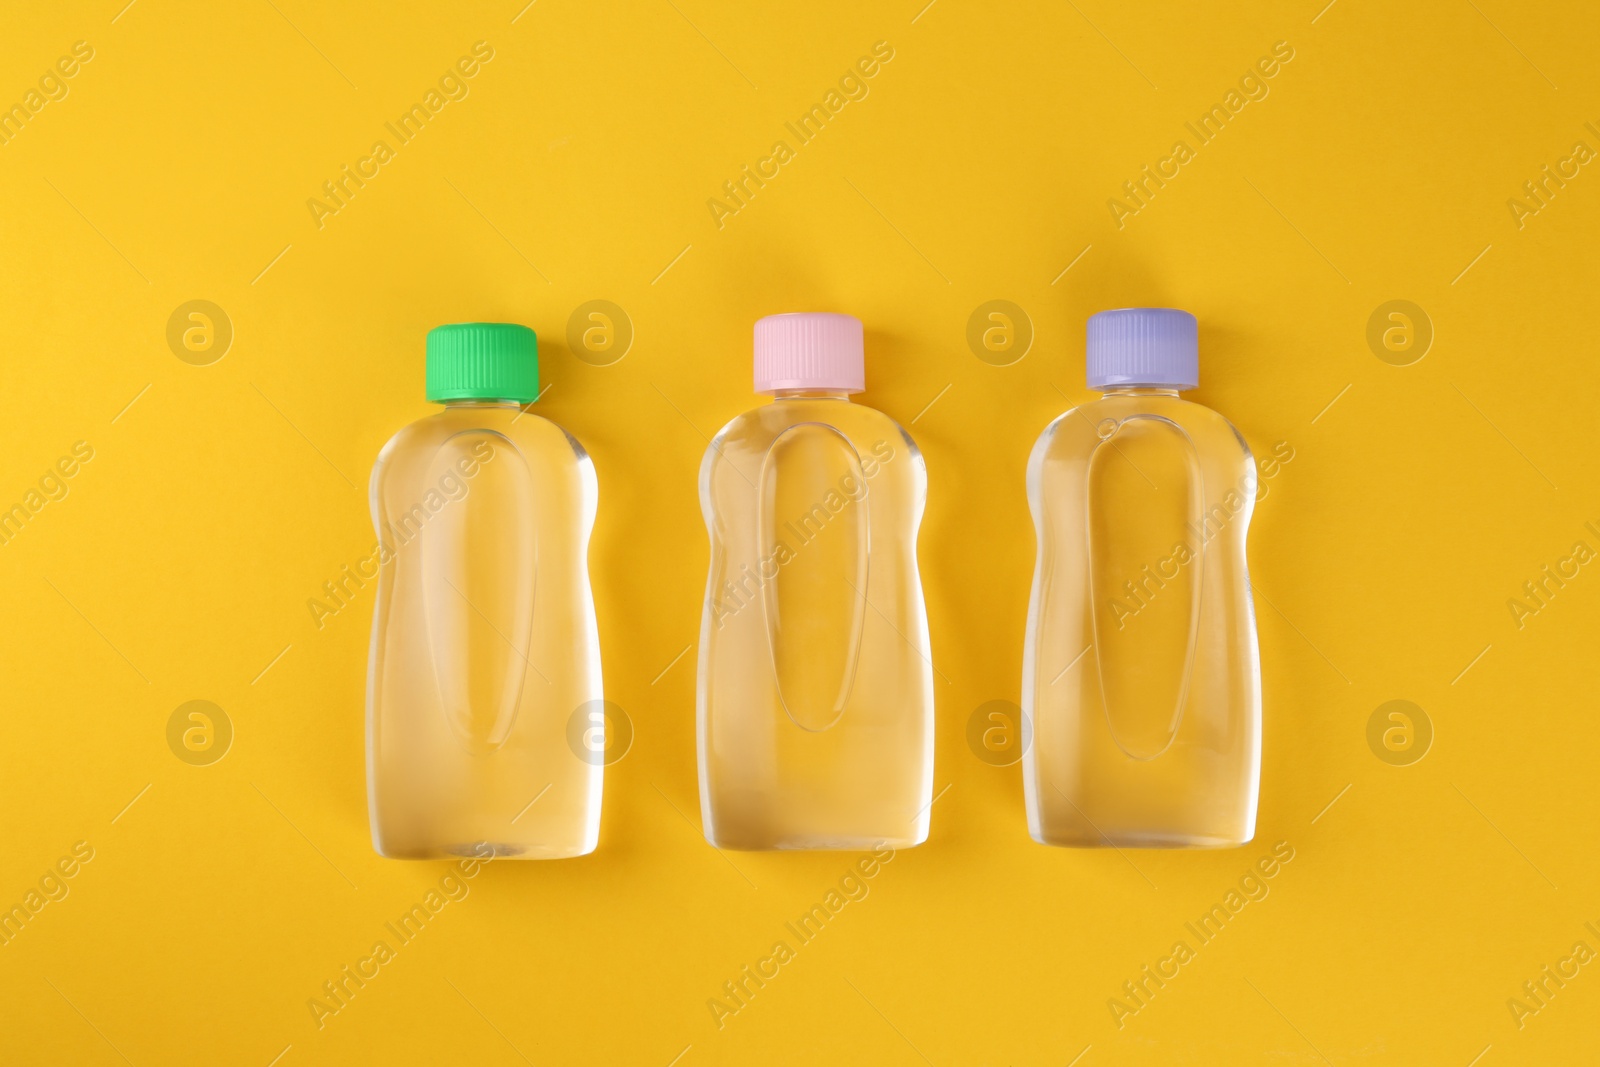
0;0;1600;1067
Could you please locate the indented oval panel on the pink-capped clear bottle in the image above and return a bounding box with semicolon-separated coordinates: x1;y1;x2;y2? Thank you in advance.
757;422;870;731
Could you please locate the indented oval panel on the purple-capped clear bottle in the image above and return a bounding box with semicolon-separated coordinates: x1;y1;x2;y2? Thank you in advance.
1085;416;1214;760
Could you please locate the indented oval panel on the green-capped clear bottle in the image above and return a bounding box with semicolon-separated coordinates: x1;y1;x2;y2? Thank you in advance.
419;430;538;752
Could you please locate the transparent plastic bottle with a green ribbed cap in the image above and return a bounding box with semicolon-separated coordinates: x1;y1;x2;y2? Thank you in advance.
366;323;602;859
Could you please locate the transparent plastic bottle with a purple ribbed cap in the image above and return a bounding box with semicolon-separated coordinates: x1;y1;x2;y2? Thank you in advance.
1022;309;1261;848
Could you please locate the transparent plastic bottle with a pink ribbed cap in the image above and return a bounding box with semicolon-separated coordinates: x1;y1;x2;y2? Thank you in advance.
698;314;933;849
